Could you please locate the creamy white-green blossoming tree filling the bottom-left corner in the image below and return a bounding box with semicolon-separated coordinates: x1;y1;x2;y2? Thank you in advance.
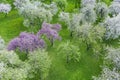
0;50;28;80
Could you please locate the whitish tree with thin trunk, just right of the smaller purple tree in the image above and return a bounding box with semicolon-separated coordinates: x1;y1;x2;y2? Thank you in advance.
59;12;82;36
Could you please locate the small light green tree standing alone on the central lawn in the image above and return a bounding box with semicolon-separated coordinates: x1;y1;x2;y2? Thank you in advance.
58;41;81;63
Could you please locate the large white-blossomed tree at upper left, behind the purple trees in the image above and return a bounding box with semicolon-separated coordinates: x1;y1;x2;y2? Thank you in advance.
14;0;58;30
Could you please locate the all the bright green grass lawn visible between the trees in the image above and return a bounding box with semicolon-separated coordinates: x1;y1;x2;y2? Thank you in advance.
0;1;118;80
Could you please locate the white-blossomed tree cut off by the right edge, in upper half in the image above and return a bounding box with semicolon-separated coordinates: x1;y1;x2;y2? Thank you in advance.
104;14;120;40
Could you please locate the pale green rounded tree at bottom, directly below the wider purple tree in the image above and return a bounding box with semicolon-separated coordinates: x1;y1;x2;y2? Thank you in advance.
28;50;51;80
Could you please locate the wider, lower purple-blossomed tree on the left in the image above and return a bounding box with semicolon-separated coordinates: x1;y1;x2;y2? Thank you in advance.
8;32;45;53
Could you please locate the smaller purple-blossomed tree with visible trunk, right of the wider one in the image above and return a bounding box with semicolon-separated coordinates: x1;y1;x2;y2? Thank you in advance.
37;22;61;46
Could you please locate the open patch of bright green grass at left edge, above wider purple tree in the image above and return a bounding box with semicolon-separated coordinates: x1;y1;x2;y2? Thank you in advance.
0;10;26;42
